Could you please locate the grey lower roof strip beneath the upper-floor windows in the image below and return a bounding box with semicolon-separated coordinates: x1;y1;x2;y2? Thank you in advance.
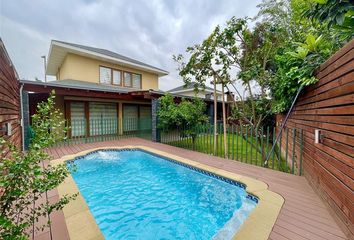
20;79;141;93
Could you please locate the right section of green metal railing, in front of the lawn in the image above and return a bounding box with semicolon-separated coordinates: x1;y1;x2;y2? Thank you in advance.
161;124;303;175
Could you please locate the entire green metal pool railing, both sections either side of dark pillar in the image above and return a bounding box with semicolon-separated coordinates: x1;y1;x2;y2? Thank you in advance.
42;117;304;175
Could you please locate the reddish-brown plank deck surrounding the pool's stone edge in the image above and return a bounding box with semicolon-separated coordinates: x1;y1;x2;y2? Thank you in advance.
35;138;348;240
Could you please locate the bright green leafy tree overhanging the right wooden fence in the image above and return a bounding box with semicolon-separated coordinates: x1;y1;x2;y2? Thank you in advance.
256;0;348;113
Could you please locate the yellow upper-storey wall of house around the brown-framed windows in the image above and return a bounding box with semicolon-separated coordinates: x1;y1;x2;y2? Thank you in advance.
57;53;158;90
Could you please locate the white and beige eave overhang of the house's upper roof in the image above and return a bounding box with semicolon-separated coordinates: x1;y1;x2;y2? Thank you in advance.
46;41;168;77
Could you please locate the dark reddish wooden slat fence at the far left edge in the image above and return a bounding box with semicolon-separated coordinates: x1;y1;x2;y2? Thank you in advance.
0;38;22;154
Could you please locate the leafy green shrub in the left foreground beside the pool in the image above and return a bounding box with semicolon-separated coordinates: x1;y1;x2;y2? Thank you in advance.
0;93;77;239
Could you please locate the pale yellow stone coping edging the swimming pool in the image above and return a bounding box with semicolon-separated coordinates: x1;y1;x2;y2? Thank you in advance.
51;145;284;240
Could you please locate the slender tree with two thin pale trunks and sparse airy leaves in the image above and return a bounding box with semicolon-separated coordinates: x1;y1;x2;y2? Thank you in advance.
174;18;252;157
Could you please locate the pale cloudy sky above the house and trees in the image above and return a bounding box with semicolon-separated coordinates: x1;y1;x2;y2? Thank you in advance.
0;0;261;90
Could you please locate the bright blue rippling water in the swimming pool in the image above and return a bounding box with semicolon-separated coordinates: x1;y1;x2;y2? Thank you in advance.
72;150;256;240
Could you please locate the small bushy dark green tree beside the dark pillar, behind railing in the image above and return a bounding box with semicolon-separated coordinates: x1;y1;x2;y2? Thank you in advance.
157;94;208;149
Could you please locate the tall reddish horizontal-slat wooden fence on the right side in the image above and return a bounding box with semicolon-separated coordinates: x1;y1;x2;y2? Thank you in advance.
277;40;354;238
